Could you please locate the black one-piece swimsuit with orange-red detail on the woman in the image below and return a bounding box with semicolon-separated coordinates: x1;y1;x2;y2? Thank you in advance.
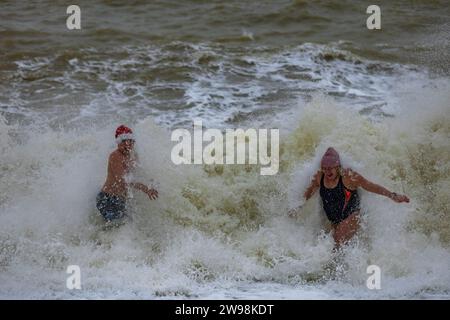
320;175;360;224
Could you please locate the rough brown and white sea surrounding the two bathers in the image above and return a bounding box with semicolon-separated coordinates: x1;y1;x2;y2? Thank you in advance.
0;0;450;299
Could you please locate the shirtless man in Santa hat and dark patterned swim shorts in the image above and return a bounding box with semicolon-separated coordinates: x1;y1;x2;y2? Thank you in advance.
97;125;158;222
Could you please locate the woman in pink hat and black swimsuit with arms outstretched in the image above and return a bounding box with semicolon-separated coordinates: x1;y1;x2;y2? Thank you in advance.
289;148;409;248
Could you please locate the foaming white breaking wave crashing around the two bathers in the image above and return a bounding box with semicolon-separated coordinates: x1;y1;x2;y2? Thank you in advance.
0;76;450;299
